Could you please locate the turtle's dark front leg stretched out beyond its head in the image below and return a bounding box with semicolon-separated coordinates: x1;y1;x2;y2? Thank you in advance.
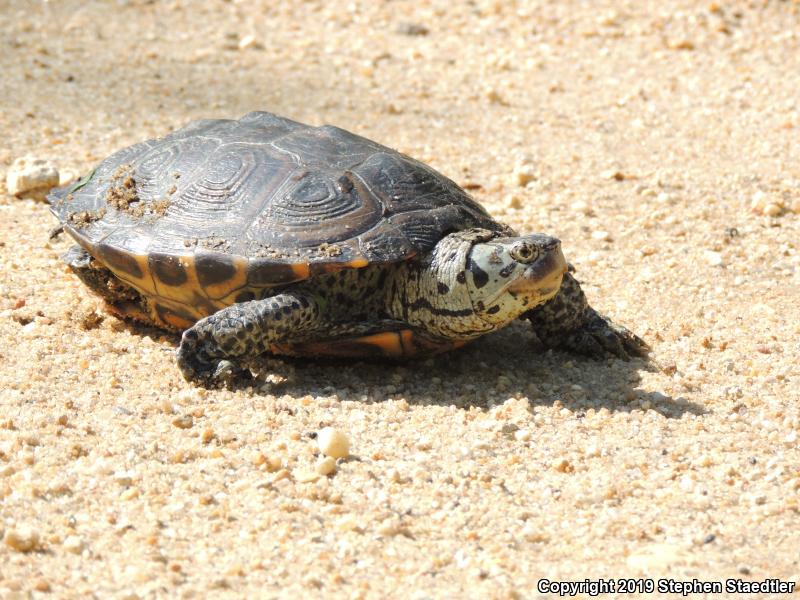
522;273;650;360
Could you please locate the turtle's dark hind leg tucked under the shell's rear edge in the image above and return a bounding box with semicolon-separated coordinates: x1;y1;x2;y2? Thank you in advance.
61;246;157;325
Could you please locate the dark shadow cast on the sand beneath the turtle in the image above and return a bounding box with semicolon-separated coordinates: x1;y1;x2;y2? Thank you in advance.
241;323;707;418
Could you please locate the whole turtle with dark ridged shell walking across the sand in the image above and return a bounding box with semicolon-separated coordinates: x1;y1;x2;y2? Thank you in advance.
48;112;648;386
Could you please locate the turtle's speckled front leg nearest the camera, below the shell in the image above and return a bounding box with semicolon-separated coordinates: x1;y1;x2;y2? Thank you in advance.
178;293;320;384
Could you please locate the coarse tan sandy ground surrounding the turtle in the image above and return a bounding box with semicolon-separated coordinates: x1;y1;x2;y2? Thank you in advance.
0;0;800;598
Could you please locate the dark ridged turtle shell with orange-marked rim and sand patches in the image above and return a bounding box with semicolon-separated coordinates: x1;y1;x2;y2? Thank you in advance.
48;112;506;328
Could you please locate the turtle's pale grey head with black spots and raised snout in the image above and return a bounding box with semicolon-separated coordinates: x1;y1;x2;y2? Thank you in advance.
465;233;567;325
